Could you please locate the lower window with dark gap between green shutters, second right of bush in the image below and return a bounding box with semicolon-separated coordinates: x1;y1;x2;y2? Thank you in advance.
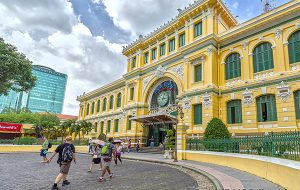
256;95;277;122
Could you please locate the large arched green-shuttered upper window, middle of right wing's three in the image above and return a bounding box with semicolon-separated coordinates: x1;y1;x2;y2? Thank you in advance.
253;42;274;73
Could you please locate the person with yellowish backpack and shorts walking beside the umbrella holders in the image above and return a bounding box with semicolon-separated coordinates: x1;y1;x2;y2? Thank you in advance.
99;138;116;182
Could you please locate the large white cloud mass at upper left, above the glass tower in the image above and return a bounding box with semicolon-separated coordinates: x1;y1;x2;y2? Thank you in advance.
0;0;126;115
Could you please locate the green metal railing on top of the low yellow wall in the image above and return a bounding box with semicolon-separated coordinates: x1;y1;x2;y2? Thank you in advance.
186;132;300;160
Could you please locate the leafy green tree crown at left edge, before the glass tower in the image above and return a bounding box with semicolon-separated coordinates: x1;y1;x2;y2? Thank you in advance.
0;38;36;95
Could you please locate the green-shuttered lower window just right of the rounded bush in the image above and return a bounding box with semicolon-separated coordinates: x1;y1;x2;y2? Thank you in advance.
227;100;242;124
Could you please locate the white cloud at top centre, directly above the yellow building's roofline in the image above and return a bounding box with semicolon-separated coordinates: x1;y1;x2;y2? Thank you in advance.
103;0;194;37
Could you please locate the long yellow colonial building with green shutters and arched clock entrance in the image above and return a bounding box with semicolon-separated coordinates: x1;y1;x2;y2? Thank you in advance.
77;0;300;145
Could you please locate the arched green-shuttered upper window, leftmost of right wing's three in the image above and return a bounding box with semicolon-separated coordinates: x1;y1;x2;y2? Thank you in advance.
225;53;241;80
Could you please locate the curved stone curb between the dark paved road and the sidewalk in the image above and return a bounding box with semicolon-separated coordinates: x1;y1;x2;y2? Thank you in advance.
122;157;224;190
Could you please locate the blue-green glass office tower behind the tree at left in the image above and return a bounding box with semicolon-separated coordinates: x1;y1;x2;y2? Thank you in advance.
0;65;68;114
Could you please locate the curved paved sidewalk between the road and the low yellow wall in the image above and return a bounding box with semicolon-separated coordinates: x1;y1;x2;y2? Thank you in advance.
122;153;284;190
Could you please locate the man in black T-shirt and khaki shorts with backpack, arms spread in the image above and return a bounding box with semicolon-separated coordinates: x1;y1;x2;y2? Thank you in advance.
46;136;76;190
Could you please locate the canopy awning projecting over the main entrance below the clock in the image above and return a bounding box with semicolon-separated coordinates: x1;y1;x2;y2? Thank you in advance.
130;113;177;125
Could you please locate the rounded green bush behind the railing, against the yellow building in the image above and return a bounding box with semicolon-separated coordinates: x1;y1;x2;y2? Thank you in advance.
204;118;230;139
